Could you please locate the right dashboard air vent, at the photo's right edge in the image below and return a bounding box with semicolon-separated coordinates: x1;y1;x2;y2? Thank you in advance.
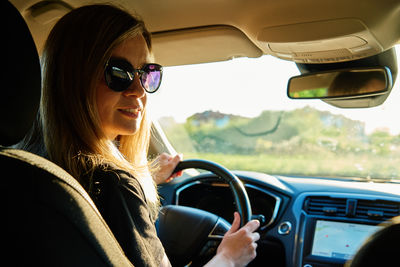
355;200;400;220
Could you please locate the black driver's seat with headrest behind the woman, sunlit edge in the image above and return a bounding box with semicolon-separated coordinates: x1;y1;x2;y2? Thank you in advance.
0;1;132;266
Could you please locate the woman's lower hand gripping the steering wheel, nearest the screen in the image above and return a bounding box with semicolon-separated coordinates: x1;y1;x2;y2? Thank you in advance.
206;212;260;267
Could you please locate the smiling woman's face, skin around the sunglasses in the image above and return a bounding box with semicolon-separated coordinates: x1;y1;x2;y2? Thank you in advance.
97;34;150;140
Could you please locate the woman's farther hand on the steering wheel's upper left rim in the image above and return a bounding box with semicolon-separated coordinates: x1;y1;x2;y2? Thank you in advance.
153;153;182;184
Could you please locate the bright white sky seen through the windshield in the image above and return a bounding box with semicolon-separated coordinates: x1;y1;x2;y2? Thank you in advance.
148;46;400;134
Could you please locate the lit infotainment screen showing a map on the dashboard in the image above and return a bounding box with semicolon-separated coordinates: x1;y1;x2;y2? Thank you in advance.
311;220;382;260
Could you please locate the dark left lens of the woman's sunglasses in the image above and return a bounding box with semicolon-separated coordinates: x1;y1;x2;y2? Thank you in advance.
105;59;134;92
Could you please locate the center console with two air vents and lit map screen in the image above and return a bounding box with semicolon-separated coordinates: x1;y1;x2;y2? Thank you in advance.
295;194;399;267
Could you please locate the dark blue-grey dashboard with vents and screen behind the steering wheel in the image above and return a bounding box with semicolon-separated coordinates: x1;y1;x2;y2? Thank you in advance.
159;171;400;267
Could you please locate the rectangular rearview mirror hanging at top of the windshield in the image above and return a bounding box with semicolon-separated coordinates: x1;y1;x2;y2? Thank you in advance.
287;67;392;99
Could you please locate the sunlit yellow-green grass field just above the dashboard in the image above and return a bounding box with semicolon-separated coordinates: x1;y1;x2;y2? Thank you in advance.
180;153;400;182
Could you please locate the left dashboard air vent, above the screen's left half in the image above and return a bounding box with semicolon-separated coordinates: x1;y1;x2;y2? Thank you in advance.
304;197;346;217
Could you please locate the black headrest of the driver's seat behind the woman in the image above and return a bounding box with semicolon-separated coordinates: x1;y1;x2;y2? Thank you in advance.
0;1;41;146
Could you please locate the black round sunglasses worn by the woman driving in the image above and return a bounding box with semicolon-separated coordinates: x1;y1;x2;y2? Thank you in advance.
104;58;163;93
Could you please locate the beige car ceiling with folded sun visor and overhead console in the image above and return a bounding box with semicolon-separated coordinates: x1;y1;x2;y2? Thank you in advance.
10;0;400;66
